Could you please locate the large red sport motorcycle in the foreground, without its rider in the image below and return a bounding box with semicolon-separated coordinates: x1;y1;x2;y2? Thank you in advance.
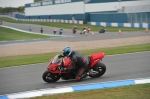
42;52;106;83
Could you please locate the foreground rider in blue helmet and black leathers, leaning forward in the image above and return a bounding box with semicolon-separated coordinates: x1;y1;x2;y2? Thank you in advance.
59;46;89;81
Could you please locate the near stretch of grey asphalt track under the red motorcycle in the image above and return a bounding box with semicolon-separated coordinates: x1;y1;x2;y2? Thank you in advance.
0;52;150;95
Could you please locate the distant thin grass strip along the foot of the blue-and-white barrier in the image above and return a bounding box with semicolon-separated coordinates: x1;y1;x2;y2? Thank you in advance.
0;17;145;32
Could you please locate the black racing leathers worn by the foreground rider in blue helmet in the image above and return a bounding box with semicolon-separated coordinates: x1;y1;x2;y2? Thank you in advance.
67;51;89;80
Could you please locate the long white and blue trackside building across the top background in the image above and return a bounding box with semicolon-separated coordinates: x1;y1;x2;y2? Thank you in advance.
16;0;150;27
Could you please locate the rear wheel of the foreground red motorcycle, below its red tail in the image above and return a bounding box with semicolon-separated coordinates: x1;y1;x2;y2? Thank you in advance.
89;62;106;78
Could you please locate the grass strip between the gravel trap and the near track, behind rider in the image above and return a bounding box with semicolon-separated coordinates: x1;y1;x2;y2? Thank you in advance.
0;43;150;68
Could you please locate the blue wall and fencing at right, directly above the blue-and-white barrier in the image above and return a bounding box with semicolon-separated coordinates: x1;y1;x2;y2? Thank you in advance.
89;12;150;23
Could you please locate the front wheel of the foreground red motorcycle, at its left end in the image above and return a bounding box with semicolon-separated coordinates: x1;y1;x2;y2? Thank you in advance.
42;71;60;83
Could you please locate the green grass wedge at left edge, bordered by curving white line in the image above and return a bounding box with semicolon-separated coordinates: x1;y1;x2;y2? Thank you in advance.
0;27;51;41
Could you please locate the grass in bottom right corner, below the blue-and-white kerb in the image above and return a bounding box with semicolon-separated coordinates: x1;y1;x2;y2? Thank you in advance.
30;84;150;99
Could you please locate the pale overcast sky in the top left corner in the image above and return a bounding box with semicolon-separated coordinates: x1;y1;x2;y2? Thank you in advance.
0;0;33;7
